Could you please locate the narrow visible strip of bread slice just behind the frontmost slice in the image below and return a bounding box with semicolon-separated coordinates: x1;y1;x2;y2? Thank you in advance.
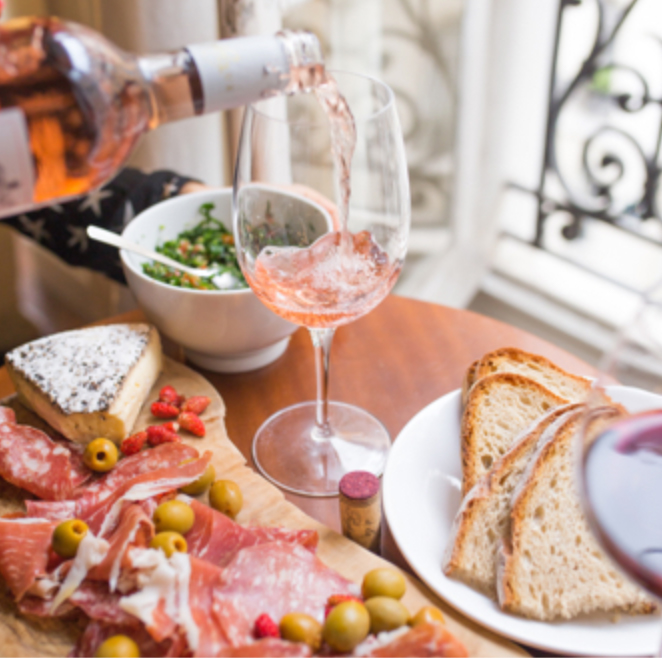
443;404;581;598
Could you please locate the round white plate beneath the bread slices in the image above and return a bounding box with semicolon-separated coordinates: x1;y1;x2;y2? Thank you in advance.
383;386;662;656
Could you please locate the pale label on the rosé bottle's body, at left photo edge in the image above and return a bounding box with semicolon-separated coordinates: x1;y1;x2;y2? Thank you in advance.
0;107;34;217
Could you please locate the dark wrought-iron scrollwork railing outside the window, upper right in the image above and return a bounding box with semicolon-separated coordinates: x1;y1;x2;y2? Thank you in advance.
528;0;662;247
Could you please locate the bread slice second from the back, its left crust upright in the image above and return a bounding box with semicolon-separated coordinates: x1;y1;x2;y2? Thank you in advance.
461;372;568;496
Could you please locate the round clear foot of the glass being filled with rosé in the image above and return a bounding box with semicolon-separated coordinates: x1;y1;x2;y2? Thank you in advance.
253;402;391;496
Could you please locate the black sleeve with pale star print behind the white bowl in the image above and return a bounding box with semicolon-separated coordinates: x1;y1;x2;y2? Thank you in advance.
0;168;200;283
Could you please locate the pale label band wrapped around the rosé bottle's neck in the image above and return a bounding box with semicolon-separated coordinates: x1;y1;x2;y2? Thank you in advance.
187;36;290;112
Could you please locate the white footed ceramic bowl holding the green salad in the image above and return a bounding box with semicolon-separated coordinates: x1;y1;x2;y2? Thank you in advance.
120;189;298;372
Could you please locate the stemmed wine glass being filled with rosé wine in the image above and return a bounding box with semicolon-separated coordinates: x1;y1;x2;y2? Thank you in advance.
233;73;411;496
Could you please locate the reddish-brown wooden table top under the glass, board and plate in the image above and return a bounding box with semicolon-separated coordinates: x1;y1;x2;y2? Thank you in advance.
0;295;593;564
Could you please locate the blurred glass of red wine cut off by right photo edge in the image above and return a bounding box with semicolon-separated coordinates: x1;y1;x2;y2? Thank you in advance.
577;282;662;656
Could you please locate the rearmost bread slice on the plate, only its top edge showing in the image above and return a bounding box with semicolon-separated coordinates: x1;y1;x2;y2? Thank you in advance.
473;347;591;402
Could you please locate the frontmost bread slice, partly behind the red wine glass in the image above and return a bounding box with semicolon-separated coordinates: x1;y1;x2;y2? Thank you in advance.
497;407;656;621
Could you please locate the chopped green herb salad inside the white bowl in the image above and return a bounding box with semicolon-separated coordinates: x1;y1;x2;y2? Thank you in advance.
143;203;248;290
